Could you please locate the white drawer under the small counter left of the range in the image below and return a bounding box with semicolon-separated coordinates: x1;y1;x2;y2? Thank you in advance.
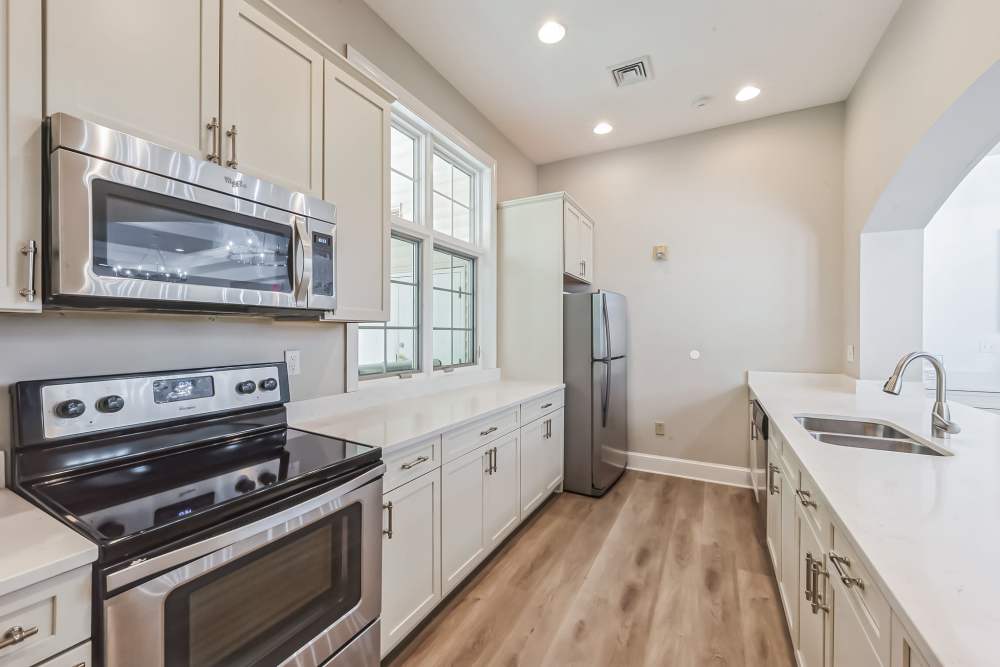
0;565;91;665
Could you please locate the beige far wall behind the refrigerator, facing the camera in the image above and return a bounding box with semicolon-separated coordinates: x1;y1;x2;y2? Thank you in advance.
539;104;844;466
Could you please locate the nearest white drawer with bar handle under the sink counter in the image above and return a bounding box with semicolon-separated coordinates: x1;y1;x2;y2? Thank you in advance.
829;529;892;665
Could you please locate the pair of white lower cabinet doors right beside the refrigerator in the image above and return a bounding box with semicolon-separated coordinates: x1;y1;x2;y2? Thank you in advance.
521;408;564;517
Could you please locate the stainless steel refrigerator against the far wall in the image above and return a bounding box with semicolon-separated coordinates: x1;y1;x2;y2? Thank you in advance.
563;291;628;496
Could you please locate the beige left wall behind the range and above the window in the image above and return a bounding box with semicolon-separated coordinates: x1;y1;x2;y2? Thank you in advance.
0;0;536;470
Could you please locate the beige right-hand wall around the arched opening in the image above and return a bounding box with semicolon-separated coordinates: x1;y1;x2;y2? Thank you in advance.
844;0;1000;375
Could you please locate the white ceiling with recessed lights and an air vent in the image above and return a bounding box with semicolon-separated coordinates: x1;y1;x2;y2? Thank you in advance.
366;0;900;164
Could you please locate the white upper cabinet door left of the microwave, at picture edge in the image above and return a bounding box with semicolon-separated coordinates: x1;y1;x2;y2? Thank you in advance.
0;0;42;312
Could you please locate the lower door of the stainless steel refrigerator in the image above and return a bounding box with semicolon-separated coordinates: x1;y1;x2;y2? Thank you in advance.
591;358;628;491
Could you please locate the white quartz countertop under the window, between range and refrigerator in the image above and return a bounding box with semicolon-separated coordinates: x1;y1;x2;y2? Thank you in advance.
289;380;565;450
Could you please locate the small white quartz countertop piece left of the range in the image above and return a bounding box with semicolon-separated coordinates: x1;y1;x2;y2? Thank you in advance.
0;489;97;595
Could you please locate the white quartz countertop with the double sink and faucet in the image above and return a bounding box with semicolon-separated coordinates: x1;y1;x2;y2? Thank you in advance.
749;372;1000;667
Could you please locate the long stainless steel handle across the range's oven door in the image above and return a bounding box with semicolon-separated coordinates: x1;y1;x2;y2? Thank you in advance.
106;464;385;595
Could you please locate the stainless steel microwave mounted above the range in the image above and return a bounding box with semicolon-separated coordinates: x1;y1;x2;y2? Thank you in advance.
46;149;334;311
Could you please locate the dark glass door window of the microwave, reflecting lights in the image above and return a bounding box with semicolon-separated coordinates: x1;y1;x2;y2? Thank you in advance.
92;180;292;293
